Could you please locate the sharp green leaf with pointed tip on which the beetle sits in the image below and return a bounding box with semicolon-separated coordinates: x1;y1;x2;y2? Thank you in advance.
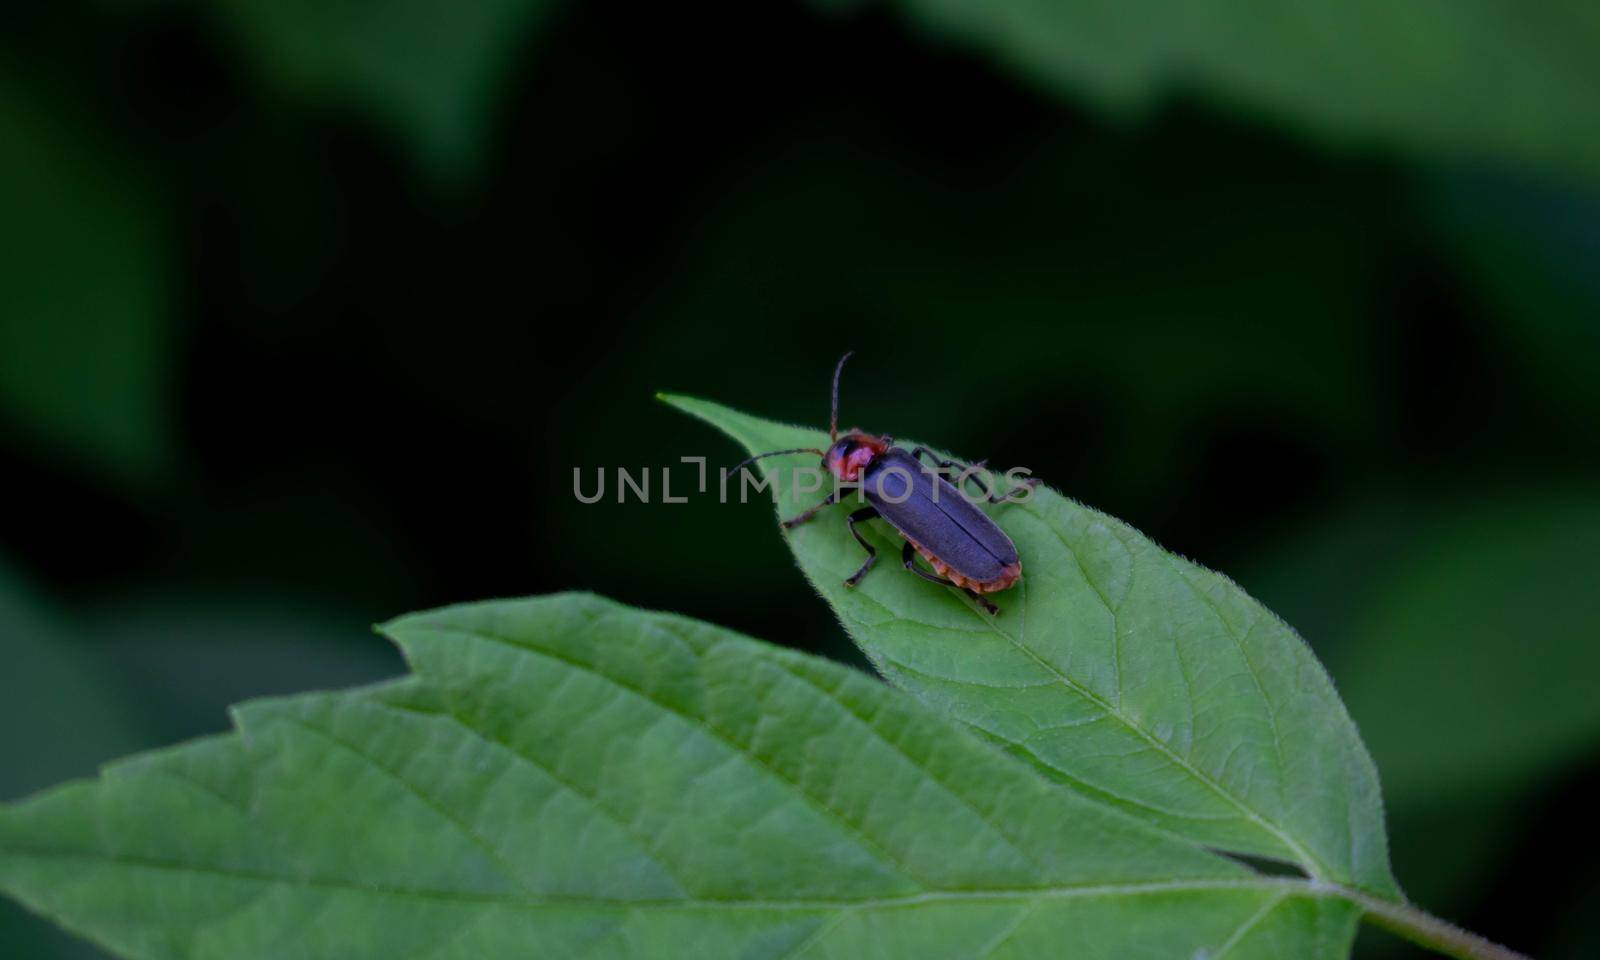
664;397;1398;898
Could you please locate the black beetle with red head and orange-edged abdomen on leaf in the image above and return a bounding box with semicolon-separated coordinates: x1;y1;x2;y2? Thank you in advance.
730;354;1037;614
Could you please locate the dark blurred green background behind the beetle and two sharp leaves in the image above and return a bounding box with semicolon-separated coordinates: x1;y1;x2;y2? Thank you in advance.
0;0;1600;960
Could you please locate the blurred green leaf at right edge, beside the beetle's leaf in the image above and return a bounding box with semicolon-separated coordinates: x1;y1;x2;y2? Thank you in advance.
1341;490;1600;813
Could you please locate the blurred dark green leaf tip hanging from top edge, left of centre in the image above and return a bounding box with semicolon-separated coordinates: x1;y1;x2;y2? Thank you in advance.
219;0;555;176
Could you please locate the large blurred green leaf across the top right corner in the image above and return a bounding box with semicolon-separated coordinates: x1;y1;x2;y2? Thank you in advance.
870;0;1600;178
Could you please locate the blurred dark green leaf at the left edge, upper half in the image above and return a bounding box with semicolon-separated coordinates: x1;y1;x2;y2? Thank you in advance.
0;77;173;482
